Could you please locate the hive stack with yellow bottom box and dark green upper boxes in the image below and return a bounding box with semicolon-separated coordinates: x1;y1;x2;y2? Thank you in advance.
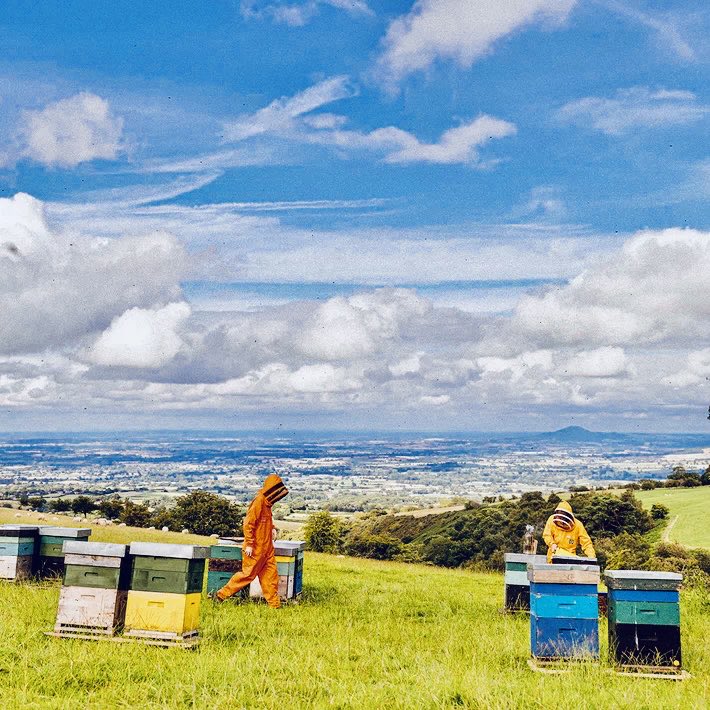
125;542;209;642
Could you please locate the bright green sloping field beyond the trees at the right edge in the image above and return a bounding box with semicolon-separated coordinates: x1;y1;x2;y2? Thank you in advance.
635;486;710;549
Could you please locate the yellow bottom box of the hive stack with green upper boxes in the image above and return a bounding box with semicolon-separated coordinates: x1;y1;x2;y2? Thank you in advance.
125;590;201;634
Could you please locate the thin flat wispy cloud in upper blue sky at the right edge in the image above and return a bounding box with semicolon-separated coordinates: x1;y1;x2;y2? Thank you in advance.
557;86;710;135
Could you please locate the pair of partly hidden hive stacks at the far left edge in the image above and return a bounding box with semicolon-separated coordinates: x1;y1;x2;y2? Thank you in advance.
0;525;91;582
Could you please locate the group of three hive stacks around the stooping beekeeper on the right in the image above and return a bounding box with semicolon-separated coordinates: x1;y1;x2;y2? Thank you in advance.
506;554;682;670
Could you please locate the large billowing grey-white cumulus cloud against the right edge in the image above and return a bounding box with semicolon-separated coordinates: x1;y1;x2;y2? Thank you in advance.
512;229;710;346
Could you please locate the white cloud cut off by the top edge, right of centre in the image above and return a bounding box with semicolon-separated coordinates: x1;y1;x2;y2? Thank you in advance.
379;0;575;81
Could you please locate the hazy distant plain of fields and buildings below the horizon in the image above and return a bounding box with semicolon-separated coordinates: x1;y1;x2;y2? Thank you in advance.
0;428;710;513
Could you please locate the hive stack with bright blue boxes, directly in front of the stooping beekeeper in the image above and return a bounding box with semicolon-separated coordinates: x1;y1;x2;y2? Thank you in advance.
528;564;600;660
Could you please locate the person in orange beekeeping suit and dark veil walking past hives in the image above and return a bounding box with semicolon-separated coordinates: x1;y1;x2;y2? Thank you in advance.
212;473;288;609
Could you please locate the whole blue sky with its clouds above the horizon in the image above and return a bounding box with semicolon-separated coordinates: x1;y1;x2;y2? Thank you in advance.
0;0;710;431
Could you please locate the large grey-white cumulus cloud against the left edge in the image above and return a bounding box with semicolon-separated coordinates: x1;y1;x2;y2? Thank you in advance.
0;193;184;354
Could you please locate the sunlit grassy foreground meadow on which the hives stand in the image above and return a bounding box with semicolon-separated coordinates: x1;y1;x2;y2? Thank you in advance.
0;516;710;710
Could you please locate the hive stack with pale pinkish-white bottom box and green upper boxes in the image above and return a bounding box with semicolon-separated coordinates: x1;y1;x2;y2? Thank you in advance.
54;540;131;636
